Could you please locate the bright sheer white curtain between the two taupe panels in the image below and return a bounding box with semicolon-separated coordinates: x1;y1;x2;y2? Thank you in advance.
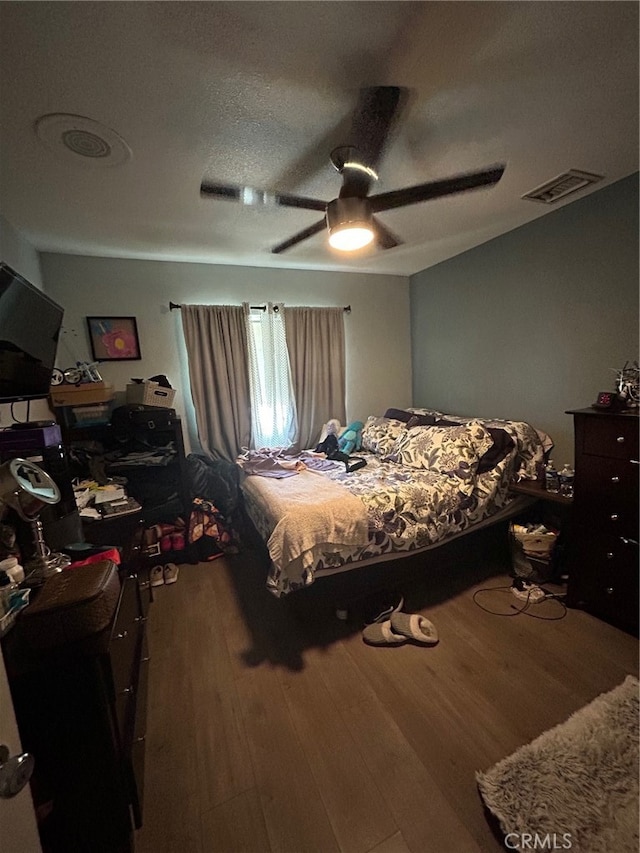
243;302;297;447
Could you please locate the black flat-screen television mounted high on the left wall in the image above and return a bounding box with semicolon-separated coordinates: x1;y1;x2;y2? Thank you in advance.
0;261;64;403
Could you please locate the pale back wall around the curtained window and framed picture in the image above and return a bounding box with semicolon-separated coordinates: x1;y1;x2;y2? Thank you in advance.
41;254;411;450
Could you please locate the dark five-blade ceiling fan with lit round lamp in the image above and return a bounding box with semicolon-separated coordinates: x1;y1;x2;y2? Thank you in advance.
200;86;505;254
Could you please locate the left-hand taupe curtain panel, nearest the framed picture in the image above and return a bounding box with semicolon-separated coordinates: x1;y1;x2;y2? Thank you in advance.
182;305;251;460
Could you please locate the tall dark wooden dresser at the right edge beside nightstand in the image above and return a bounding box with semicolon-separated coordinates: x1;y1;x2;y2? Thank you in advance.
567;409;639;635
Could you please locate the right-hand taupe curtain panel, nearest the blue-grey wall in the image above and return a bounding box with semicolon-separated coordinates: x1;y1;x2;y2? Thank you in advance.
284;308;346;450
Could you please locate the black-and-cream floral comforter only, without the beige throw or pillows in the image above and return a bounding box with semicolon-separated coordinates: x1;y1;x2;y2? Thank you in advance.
242;410;544;596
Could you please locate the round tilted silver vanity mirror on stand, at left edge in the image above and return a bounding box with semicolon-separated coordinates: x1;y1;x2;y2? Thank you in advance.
0;458;71;581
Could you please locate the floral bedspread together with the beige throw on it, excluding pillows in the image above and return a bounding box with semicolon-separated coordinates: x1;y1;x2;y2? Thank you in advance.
241;410;544;596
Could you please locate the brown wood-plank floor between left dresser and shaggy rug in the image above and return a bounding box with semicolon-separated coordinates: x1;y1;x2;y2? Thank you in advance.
136;529;638;853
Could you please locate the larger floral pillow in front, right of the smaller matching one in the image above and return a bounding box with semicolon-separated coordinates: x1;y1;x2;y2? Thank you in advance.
391;421;493;495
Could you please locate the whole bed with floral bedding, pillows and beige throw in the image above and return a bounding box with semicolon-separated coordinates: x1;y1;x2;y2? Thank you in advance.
238;408;553;596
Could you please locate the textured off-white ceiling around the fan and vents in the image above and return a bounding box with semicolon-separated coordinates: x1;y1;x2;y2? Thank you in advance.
0;2;638;275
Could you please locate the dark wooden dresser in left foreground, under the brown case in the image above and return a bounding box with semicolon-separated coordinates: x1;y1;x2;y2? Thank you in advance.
0;563;149;853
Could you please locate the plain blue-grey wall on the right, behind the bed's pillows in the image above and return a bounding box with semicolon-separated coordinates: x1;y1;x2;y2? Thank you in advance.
410;174;638;463
